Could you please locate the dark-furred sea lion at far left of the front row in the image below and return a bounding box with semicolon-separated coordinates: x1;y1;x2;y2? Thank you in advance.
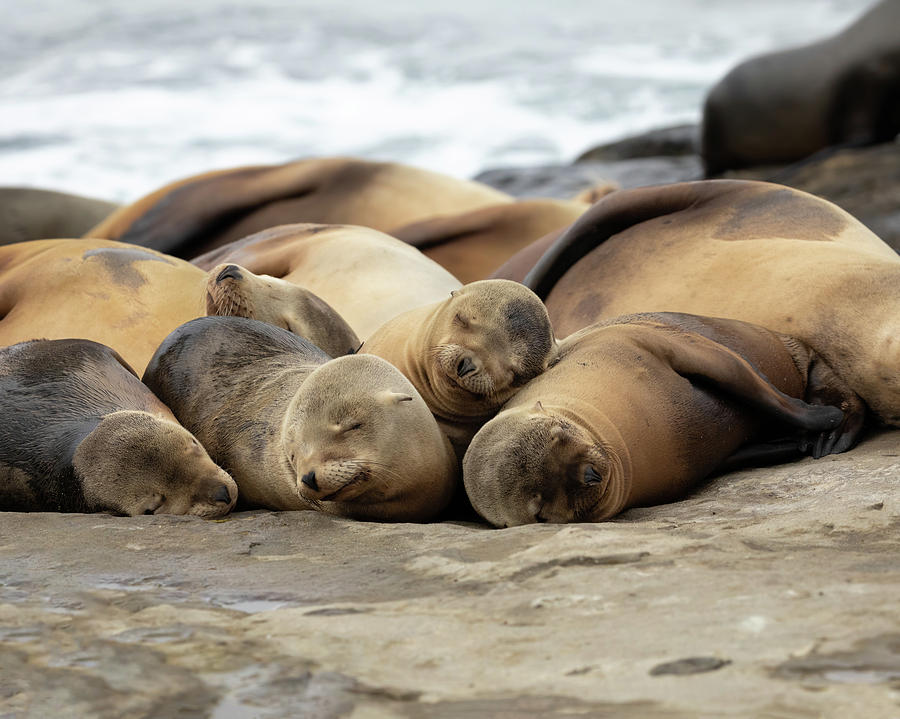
0;339;237;517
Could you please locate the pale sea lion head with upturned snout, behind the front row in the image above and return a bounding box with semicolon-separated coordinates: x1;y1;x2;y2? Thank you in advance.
206;264;360;357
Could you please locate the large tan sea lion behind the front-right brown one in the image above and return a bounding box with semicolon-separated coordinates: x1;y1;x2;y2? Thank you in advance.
512;180;900;425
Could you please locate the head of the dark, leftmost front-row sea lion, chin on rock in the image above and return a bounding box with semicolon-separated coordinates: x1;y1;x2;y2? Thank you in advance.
74;411;237;518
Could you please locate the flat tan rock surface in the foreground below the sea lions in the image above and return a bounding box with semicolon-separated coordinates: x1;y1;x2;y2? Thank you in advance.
0;430;900;719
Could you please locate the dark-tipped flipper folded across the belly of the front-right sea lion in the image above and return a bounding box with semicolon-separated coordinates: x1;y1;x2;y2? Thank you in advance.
653;332;844;432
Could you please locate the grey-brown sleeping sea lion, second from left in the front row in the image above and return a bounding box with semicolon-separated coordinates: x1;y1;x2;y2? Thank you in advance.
144;317;457;521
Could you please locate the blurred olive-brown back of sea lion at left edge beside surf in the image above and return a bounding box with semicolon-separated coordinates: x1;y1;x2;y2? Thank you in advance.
0;187;118;245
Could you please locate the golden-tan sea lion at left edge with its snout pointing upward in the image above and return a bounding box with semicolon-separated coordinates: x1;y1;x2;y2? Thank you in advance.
0;240;359;372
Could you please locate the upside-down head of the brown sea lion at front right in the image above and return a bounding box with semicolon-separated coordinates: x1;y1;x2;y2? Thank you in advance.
463;402;630;527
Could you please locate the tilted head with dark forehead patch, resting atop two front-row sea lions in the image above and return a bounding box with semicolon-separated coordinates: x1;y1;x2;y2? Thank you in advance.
425;280;556;419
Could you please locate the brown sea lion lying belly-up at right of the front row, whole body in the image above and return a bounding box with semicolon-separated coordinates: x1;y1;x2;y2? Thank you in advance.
463;313;863;527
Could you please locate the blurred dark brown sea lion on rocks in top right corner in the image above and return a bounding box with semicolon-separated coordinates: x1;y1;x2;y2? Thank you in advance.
702;0;900;175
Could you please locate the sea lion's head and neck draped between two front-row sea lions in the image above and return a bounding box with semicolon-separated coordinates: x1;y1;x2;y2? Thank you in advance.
360;280;556;456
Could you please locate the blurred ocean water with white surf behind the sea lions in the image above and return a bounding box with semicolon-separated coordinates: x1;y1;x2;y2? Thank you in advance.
0;0;872;201
